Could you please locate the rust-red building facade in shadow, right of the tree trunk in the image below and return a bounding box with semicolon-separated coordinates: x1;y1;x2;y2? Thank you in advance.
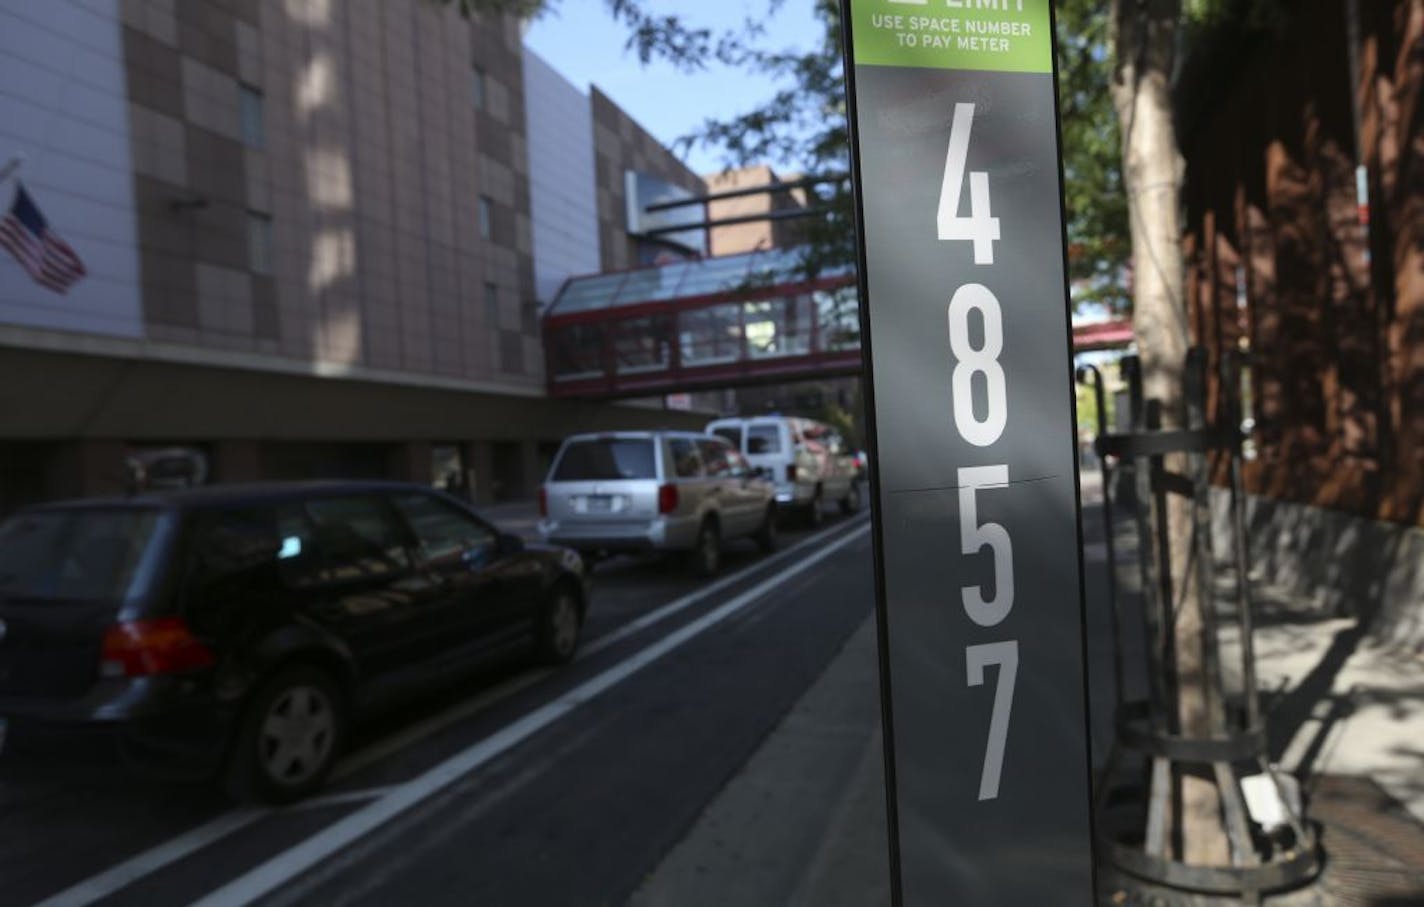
1178;0;1424;646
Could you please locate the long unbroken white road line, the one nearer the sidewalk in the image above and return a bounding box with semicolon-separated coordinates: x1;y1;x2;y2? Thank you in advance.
194;527;867;907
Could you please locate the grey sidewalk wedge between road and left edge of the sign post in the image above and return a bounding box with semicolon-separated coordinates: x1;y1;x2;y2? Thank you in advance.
628;619;890;907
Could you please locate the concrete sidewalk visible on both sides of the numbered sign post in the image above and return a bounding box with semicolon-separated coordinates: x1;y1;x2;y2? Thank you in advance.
629;471;1424;907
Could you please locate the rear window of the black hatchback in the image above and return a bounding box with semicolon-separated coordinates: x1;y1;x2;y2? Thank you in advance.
0;508;159;601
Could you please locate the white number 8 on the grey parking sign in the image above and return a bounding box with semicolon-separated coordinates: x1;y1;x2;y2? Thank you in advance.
950;283;1008;447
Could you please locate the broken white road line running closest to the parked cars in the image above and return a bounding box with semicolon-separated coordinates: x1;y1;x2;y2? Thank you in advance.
36;515;857;907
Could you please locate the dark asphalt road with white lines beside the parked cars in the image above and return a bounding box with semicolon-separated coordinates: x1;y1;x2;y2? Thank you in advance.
0;506;873;907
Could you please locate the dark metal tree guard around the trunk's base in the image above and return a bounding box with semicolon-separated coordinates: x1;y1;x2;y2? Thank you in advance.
1078;349;1320;903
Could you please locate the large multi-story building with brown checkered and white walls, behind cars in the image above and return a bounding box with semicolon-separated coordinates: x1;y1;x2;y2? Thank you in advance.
0;0;723;510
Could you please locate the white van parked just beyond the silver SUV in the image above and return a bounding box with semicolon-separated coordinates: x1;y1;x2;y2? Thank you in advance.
706;416;862;525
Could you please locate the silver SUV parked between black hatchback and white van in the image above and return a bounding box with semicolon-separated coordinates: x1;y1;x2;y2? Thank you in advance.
540;431;776;575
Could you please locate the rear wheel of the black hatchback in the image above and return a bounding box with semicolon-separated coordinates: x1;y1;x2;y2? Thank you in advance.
228;665;346;803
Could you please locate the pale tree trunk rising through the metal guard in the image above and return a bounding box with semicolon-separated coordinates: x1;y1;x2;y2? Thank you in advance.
1112;0;1229;864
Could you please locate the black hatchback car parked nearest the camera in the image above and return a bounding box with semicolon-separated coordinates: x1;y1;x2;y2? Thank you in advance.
0;483;587;802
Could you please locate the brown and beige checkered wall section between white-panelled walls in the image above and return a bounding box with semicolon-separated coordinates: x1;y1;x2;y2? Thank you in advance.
122;0;543;386
